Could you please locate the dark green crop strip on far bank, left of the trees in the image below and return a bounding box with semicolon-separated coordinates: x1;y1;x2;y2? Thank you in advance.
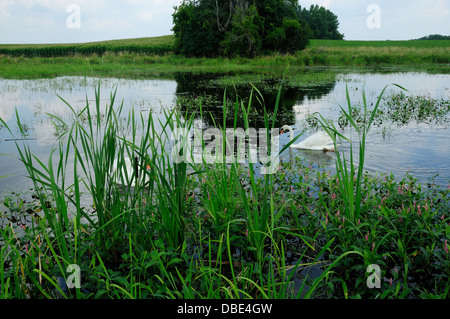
0;44;173;58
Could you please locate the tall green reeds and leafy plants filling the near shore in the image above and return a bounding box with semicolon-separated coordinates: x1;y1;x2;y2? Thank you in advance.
0;82;450;299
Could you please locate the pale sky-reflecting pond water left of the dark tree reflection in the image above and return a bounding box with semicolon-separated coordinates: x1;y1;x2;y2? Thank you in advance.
0;77;177;194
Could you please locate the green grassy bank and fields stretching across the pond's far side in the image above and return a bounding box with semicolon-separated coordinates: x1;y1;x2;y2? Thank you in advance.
0;36;450;78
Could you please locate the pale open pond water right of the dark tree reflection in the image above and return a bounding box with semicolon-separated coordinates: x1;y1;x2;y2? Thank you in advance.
293;73;450;186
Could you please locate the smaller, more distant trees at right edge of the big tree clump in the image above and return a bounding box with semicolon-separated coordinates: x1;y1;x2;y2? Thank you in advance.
299;5;344;40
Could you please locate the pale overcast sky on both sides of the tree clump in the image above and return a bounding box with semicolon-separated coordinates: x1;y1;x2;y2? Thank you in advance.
0;0;450;43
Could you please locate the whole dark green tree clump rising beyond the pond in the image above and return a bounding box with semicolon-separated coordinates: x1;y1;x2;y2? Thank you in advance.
172;0;344;57
